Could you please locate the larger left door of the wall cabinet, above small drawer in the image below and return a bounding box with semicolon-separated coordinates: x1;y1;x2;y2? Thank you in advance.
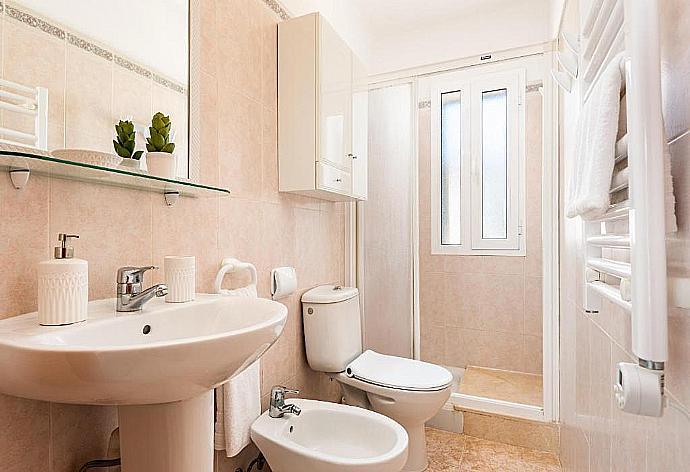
318;18;352;172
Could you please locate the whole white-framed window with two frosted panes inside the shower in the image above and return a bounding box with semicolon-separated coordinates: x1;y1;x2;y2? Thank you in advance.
430;70;525;256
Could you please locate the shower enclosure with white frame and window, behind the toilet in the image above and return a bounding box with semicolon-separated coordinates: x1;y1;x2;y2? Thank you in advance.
357;53;558;420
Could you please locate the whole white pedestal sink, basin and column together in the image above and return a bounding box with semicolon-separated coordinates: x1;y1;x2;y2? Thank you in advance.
0;295;287;472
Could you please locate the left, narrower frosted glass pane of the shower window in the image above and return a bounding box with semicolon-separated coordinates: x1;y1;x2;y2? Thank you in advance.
440;90;462;245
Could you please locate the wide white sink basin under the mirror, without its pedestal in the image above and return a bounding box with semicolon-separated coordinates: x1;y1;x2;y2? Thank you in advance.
0;295;287;405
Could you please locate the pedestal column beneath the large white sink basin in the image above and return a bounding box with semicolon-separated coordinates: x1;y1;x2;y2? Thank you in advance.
118;390;214;472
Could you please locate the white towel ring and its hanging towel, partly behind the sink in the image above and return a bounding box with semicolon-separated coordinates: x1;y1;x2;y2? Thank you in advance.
214;259;261;457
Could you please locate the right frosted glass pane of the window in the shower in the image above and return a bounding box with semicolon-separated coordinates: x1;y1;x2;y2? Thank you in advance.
482;89;508;239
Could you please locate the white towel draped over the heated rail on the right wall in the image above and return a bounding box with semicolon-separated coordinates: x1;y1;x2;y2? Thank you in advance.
566;54;623;220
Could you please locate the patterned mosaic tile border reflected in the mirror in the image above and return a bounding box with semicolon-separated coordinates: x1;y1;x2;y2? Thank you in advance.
0;0;185;95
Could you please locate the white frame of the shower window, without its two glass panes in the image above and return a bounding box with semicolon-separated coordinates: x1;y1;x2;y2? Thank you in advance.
430;69;525;256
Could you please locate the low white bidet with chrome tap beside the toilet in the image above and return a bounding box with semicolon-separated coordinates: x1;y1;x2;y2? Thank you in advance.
251;399;408;472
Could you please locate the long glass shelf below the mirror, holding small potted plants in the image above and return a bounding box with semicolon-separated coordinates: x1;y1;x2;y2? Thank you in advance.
0;145;230;198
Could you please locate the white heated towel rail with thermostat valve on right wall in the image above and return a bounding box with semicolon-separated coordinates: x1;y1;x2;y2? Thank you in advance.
580;0;668;416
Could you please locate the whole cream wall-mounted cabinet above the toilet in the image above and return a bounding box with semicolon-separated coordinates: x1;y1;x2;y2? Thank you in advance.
278;13;368;201
